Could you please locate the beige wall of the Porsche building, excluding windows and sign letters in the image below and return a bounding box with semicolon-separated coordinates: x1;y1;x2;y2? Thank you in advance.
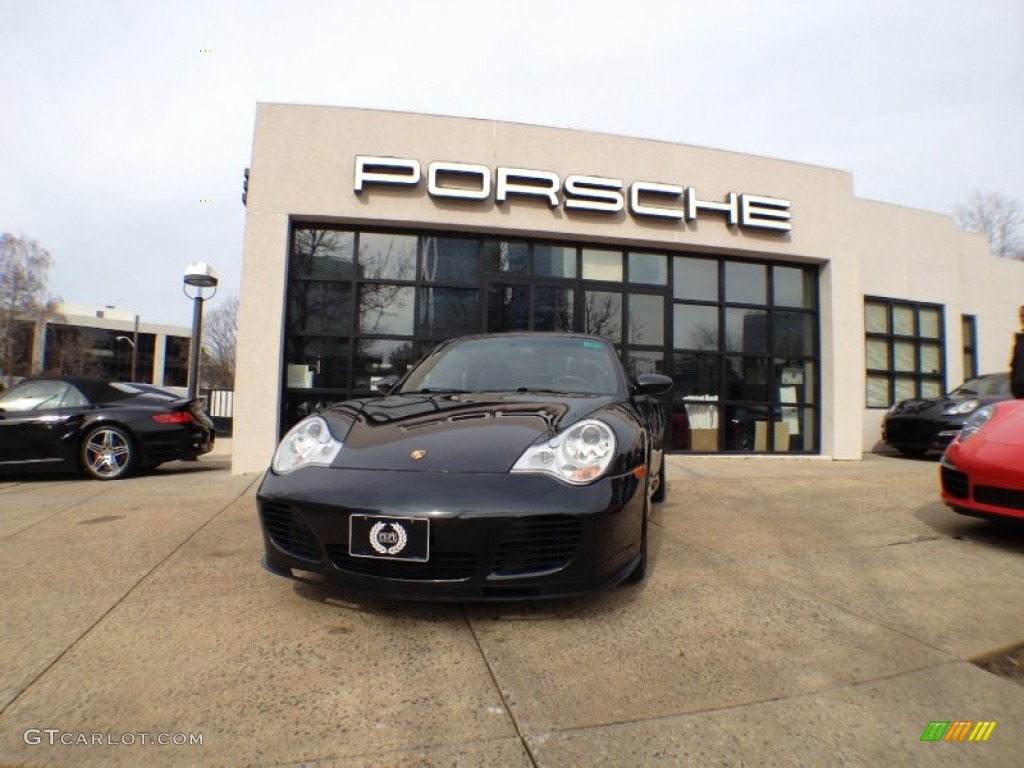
232;104;1015;472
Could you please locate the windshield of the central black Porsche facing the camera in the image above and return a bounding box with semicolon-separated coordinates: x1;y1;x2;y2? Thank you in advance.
401;336;620;394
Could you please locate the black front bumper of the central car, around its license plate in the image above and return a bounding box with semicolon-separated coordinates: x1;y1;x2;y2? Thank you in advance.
257;467;646;600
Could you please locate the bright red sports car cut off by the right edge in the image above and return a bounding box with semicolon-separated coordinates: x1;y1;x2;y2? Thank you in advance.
940;400;1024;521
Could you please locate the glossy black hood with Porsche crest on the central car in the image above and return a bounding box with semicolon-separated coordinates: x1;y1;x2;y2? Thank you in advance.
323;392;616;472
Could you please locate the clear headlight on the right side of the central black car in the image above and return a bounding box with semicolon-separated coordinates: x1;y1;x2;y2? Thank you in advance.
512;419;615;485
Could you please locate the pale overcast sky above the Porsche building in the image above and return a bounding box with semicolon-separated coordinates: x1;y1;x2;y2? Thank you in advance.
0;0;1024;326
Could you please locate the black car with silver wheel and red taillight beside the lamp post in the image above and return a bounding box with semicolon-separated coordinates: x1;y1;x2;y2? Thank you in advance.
0;377;215;480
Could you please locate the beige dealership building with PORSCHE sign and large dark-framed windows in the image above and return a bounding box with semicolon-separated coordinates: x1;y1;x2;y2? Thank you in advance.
232;104;1024;472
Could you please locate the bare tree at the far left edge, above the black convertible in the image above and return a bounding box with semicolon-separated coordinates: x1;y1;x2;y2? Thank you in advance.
0;232;59;386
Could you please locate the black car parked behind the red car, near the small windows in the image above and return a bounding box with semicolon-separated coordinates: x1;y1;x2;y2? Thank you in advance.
882;374;1012;456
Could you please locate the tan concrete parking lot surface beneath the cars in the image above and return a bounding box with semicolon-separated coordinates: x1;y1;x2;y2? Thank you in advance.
0;454;1024;767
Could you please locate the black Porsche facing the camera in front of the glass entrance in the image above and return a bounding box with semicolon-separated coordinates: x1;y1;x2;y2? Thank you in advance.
257;334;672;600
